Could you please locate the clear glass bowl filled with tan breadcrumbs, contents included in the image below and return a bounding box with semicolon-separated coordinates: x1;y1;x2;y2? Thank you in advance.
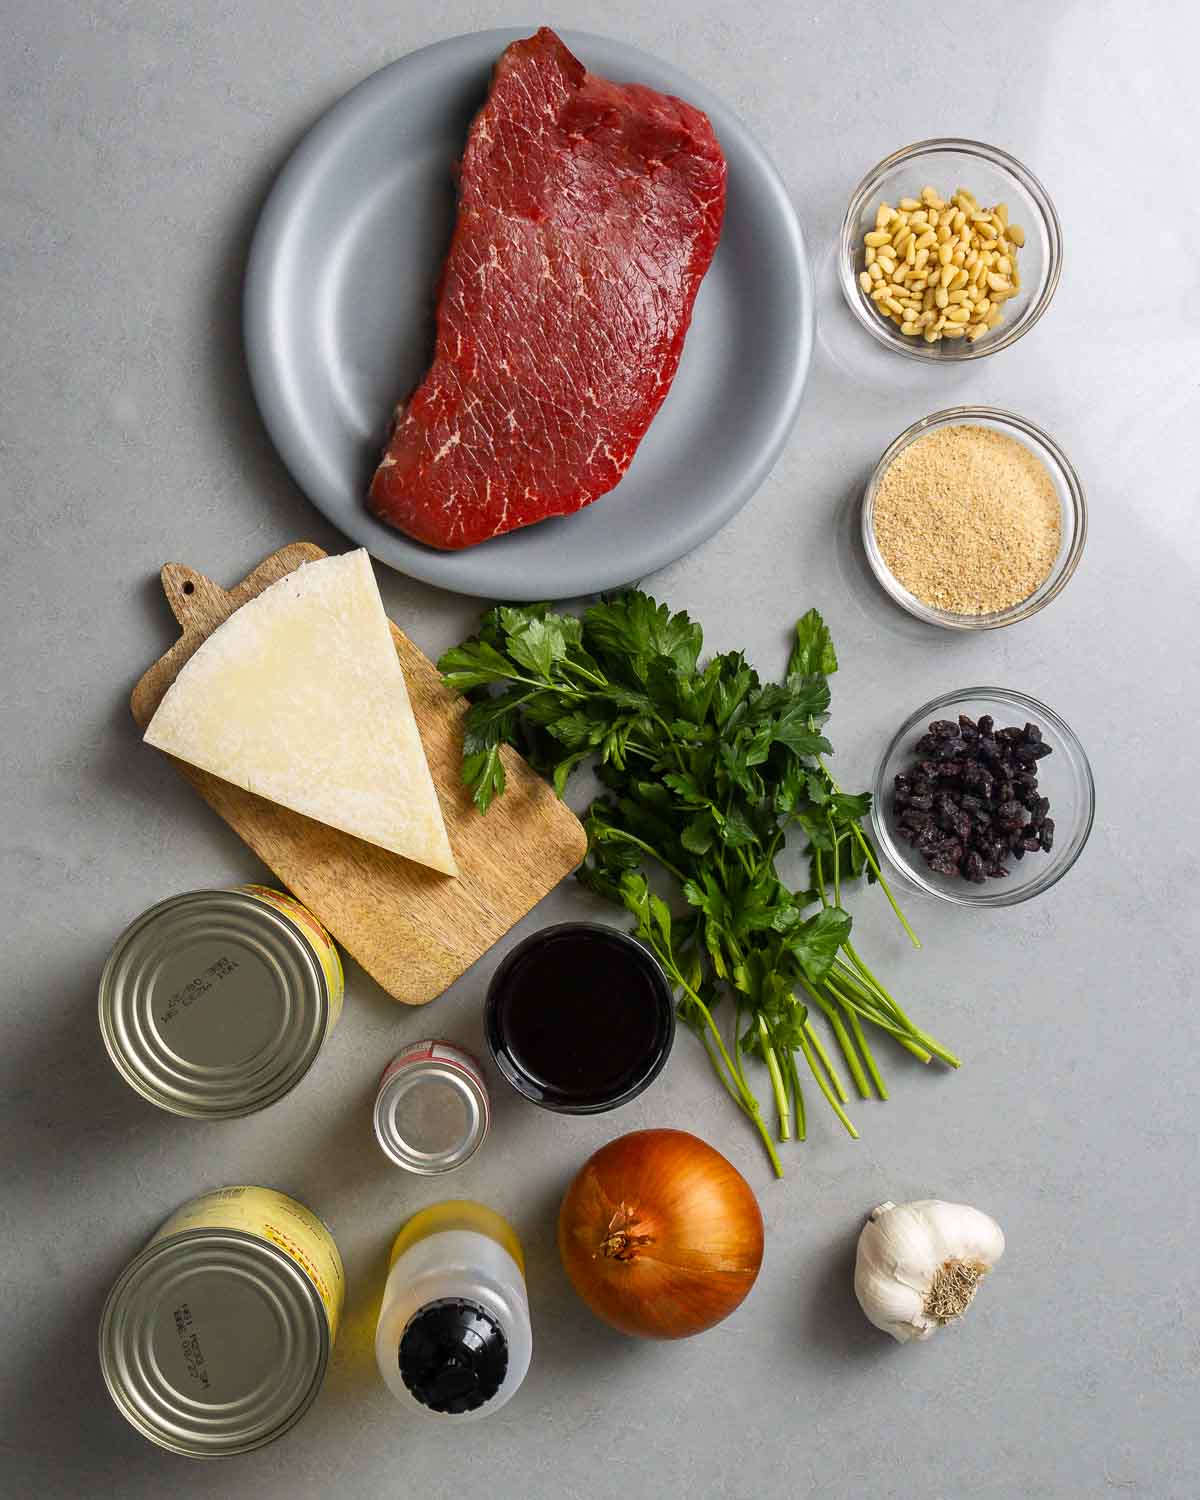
863;407;1088;630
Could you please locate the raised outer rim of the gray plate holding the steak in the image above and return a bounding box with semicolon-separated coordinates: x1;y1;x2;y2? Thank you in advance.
242;27;816;600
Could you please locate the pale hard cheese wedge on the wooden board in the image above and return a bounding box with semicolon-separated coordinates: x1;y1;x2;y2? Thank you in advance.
146;549;458;875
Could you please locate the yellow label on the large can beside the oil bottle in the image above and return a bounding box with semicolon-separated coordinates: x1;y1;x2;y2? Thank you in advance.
150;1187;347;1346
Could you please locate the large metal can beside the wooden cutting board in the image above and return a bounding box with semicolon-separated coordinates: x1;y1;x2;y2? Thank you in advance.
101;885;345;1119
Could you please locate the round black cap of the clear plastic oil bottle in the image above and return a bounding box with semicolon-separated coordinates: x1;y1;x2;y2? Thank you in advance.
399;1298;509;1415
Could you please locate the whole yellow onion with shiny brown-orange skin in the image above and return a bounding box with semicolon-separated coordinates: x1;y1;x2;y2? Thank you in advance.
558;1130;762;1338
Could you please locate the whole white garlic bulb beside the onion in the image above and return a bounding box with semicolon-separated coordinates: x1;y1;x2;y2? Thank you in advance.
854;1199;1004;1344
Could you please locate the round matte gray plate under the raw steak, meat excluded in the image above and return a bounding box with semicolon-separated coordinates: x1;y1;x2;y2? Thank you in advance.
245;30;813;599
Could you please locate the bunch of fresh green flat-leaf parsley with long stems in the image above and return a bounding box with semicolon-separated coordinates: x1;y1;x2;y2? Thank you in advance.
440;590;959;1175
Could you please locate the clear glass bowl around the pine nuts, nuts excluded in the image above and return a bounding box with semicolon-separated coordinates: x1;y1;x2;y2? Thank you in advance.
837;138;1062;360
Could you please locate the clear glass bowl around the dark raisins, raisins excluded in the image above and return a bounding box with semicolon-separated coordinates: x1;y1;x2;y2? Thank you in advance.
872;687;1095;906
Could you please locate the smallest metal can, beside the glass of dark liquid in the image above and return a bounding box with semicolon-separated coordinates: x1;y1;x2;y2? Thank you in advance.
375;1041;492;1178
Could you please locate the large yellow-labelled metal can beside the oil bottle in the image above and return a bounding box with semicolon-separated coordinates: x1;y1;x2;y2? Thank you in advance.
99;1187;345;1458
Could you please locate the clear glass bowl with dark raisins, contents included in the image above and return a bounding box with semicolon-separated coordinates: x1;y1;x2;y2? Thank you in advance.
873;687;1095;906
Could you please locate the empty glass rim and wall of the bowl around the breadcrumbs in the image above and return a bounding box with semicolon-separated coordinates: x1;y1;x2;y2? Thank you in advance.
863;407;1088;630
